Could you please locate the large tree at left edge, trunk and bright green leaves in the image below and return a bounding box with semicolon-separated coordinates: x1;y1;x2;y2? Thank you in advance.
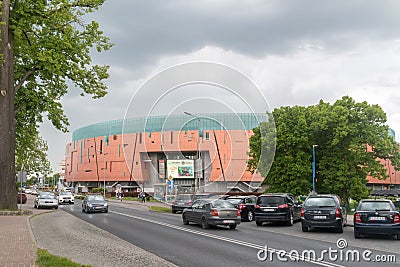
0;0;112;209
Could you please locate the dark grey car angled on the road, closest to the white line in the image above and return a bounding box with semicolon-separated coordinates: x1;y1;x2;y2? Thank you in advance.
182;199;241;229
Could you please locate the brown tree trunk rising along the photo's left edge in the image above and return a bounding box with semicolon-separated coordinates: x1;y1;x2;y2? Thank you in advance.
0;0;18;210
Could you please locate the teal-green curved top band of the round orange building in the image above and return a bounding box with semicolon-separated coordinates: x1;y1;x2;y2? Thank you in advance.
72;113;267;142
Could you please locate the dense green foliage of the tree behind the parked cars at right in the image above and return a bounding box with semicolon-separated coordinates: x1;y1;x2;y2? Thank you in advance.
249;96;400;203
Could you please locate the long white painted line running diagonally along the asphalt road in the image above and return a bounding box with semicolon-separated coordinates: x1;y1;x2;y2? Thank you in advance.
109;211;344;267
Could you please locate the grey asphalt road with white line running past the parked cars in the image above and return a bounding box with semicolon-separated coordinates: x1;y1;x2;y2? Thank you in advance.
61;201;400;266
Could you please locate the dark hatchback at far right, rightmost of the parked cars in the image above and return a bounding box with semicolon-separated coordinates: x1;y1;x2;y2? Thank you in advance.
354;199;400;240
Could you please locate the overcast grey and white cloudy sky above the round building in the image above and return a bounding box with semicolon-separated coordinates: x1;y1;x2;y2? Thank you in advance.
41;0;400;174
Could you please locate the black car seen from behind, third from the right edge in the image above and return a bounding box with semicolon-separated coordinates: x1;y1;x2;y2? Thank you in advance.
254;193;301;226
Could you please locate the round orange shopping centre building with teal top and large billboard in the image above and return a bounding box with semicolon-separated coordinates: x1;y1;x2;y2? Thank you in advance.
65;113;267;199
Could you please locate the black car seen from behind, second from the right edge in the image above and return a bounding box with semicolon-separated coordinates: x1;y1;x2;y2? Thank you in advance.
301;194;347;233
